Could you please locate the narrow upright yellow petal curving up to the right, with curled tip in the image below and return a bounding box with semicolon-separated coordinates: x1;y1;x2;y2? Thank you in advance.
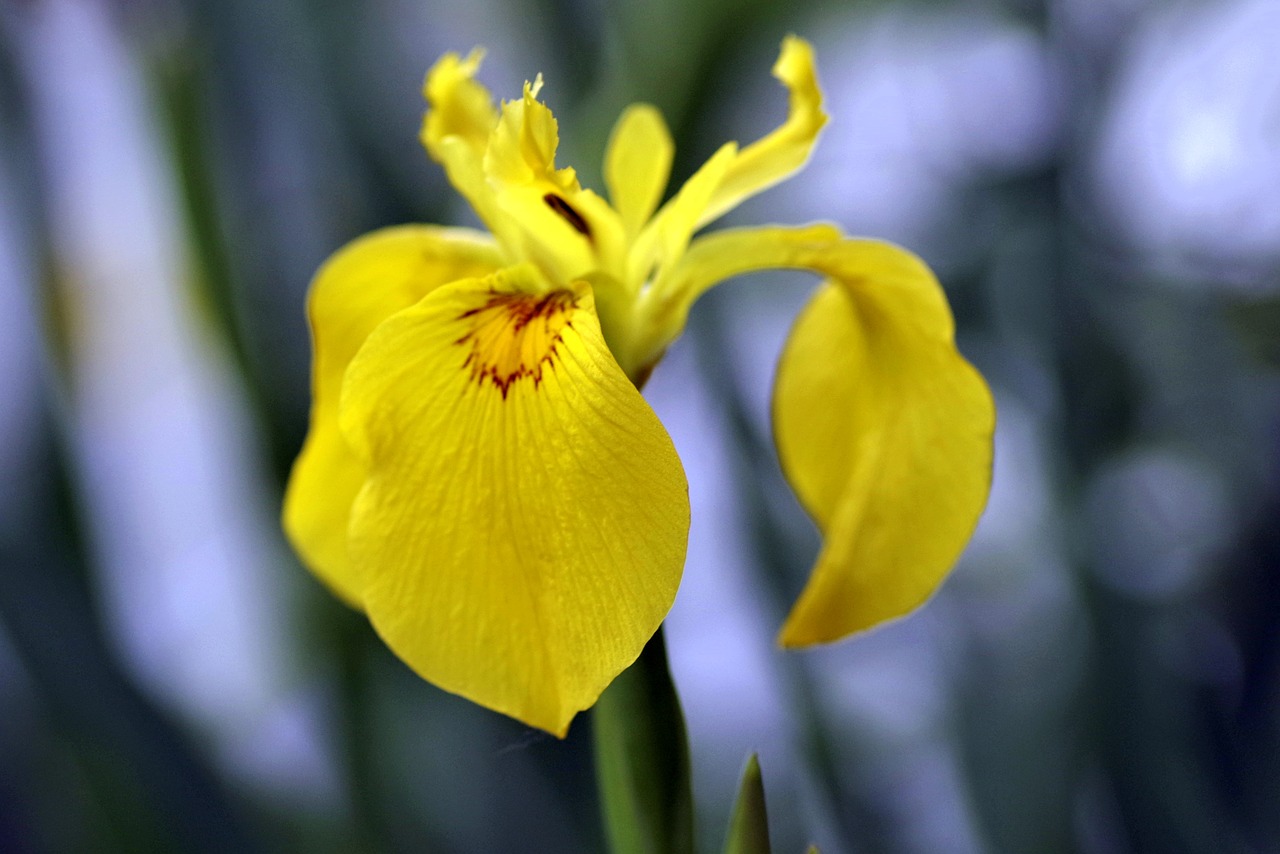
698;36;827;227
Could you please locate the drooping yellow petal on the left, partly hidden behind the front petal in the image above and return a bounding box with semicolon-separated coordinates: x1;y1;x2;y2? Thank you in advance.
284;225;499;606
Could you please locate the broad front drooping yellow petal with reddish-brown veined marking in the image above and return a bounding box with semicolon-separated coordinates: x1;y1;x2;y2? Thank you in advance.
342;268;689;735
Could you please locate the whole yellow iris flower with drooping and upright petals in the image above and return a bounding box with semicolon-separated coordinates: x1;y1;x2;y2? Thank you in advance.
284;37;995;735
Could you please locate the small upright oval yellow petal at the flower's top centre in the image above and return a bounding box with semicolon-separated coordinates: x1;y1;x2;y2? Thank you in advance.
604;104;676;237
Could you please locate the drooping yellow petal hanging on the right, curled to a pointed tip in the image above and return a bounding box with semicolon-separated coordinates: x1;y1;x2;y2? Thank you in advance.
773;241;995;647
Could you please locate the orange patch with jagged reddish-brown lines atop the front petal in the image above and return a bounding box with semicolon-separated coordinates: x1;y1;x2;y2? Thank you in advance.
454;291;577;399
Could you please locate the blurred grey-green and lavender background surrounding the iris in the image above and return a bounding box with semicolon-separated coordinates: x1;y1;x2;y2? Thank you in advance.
0;0;1280;854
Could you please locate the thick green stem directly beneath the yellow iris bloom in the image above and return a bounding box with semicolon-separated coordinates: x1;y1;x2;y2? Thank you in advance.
591;629;694;854
